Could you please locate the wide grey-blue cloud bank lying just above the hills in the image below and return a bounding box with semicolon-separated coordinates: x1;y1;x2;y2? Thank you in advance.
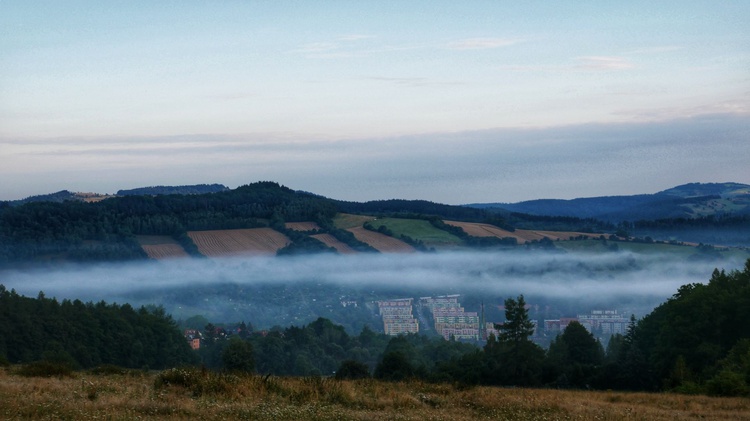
0;112;750;204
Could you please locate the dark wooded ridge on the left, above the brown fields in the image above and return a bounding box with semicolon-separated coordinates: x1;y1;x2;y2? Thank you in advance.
0;182;336;265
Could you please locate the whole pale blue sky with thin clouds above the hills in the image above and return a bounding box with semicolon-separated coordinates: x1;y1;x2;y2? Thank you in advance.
0;0;750;204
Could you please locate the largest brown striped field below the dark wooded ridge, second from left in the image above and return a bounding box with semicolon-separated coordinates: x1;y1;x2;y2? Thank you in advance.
188;228;290;257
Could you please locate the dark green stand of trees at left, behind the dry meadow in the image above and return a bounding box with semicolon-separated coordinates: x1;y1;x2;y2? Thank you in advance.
0;285;197;369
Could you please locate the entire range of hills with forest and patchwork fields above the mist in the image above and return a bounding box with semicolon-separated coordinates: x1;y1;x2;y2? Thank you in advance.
0;181;750;267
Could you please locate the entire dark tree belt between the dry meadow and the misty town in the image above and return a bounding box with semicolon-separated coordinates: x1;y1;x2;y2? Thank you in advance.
0;260;750;396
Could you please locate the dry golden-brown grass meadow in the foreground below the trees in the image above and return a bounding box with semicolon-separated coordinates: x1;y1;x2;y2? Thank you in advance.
0;369;750;421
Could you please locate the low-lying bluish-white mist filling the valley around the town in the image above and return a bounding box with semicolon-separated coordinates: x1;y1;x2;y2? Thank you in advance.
0;251;744;328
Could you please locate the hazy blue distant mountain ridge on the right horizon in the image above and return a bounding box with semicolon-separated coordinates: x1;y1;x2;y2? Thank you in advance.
466;183;750;222
